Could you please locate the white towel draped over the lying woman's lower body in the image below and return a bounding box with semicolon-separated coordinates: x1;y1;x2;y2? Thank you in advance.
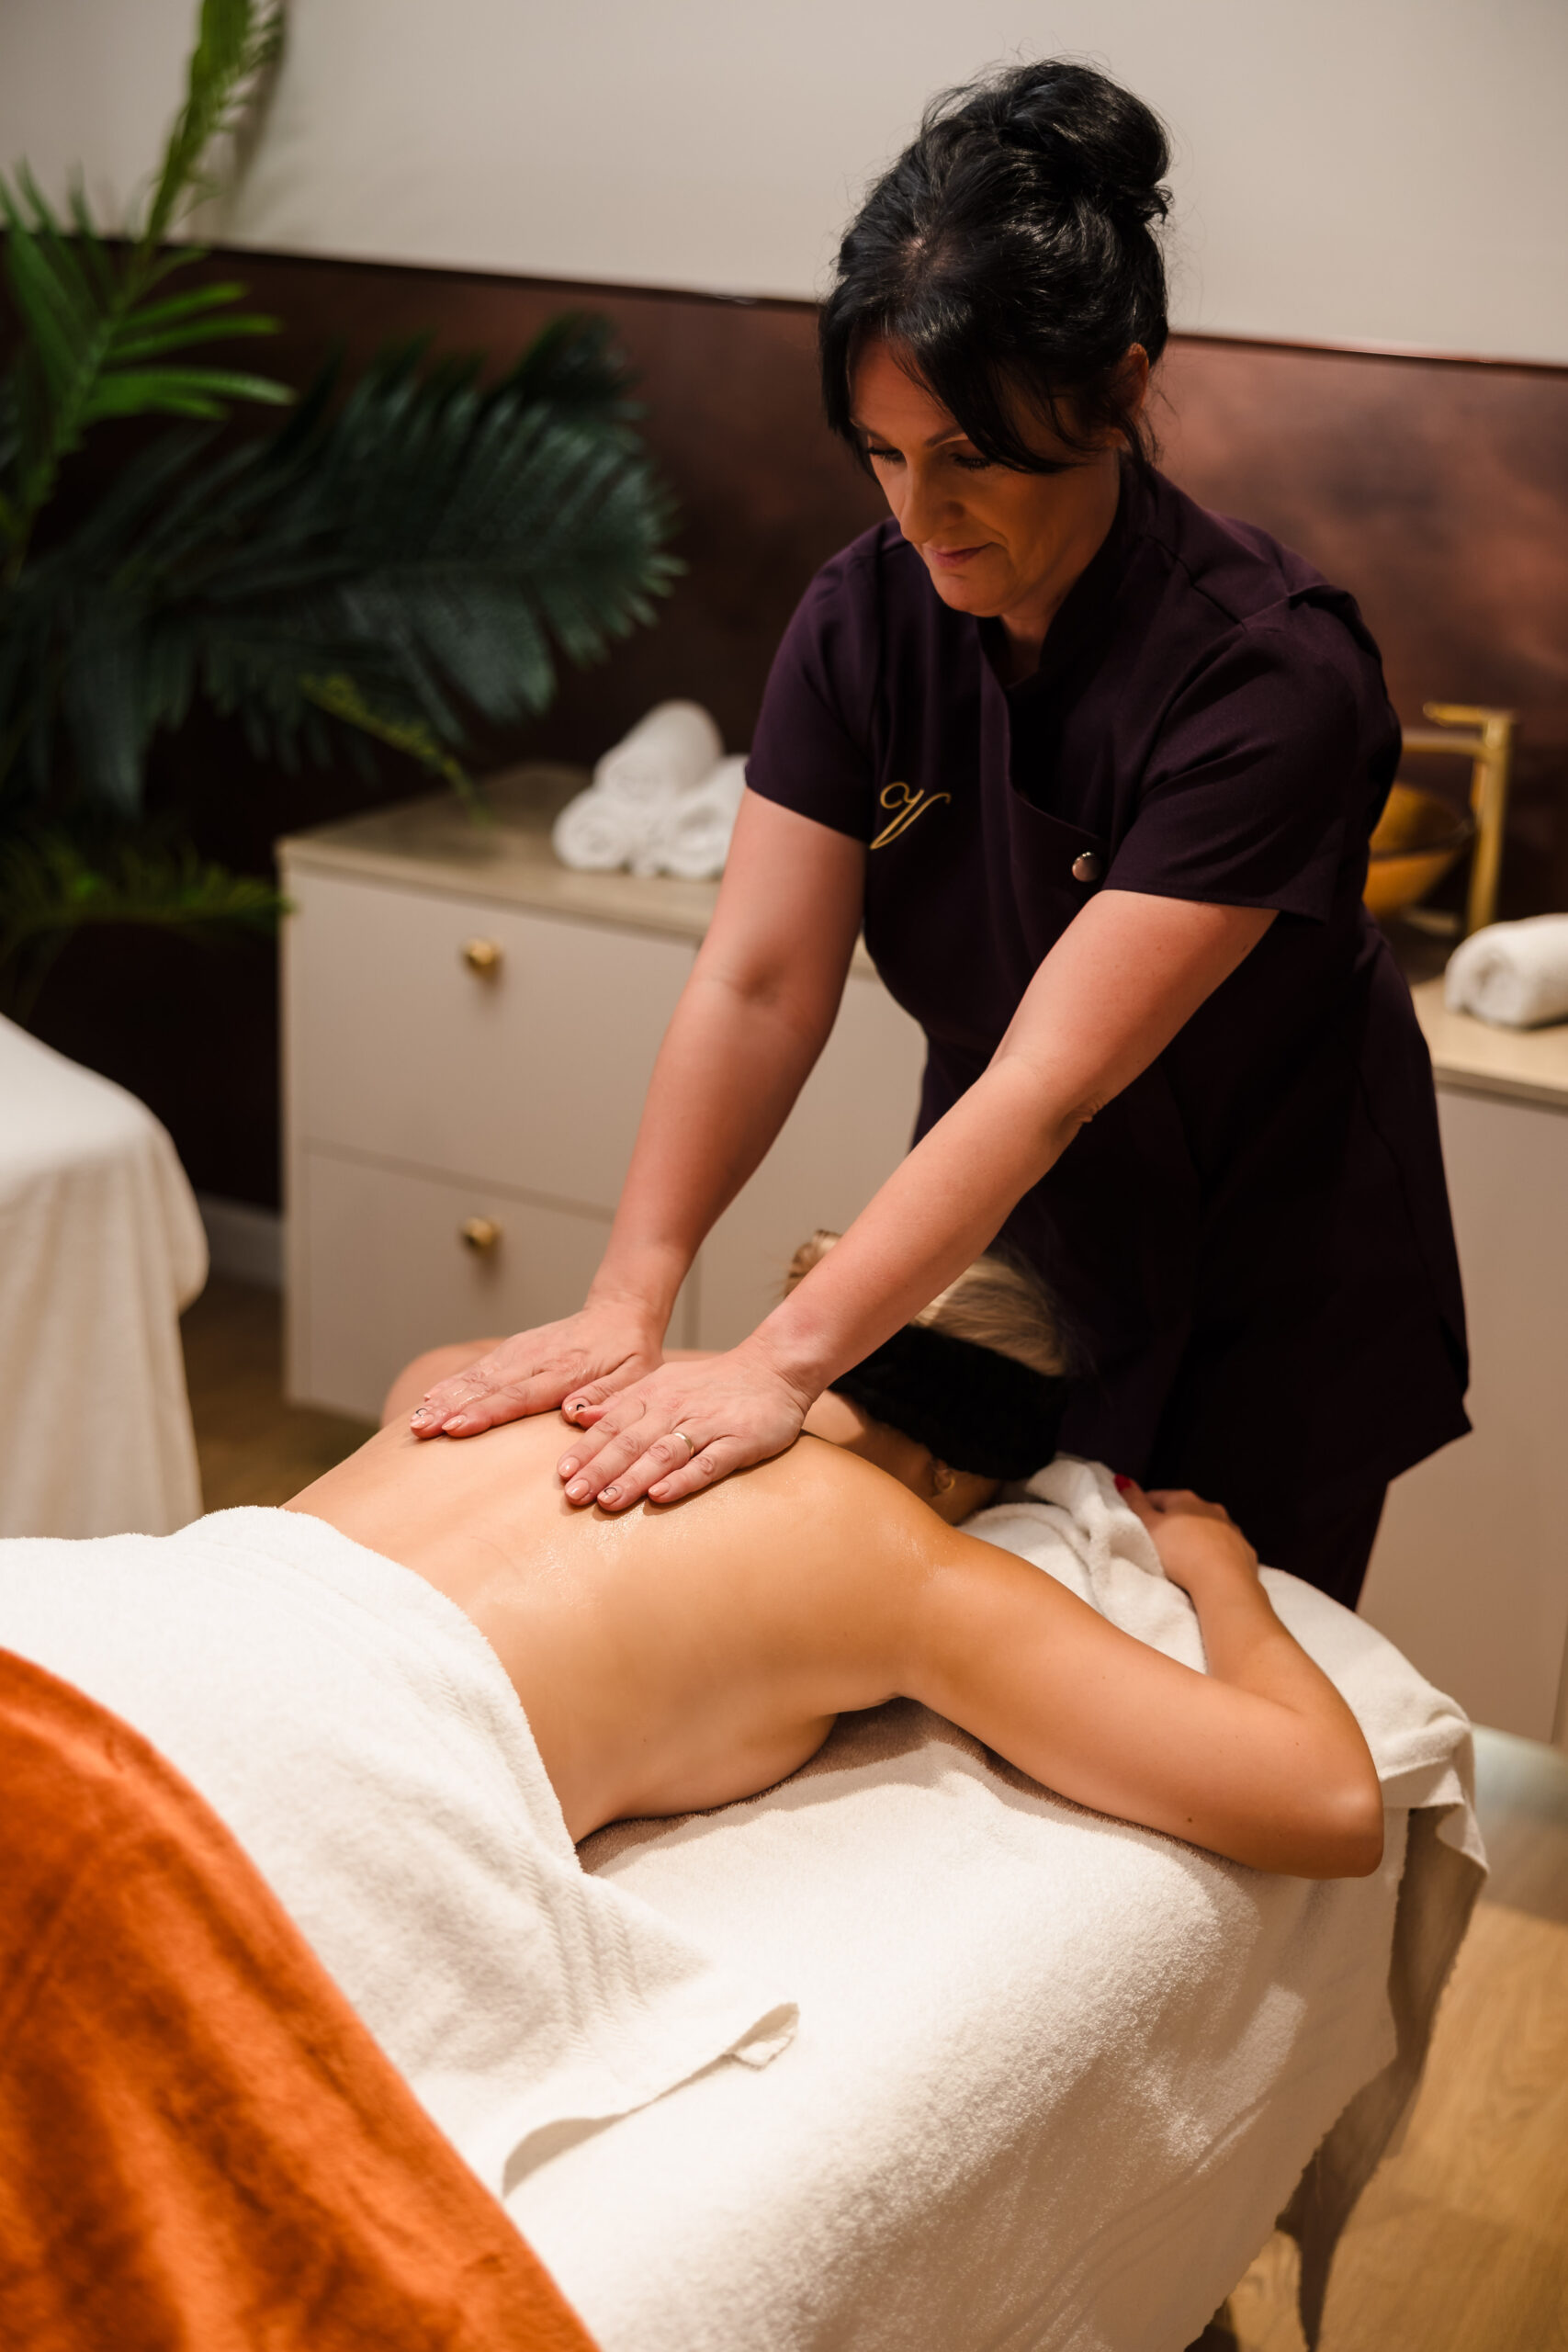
0;1510;795;2192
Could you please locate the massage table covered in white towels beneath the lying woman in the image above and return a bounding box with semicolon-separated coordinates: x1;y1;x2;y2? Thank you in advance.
0;1461;1483;2352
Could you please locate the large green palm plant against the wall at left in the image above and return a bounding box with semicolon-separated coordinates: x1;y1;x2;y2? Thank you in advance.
0;0;680;1016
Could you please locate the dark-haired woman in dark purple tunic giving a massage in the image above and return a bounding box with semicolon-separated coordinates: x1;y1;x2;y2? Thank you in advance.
413;63;1467;1604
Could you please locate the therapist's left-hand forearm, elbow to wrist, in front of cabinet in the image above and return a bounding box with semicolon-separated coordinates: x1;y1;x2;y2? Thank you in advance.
590;971;832;1336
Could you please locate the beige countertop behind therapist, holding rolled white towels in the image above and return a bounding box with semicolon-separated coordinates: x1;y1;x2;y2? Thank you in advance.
277;762;1568;1113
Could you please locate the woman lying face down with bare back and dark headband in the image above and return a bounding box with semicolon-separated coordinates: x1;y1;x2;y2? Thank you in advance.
289;1235;1382;1877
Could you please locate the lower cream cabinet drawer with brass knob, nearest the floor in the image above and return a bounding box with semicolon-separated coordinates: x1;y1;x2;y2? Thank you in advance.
289;1150;609;1420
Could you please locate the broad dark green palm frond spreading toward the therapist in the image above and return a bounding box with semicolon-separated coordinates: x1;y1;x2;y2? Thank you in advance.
0;318;680;816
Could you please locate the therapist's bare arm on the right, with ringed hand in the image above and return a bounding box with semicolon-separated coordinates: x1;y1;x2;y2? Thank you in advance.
562;889;1274;1510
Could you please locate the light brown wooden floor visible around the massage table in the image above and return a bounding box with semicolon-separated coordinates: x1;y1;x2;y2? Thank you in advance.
186;1280;1568;2352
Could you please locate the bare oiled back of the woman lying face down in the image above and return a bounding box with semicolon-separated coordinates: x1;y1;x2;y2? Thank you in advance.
289;1416;926;1837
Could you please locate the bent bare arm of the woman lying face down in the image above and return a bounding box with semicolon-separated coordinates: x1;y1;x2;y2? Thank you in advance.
900;1488;1382;1879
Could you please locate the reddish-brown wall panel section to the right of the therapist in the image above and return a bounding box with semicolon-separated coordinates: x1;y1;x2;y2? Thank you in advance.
1159;336;1568;912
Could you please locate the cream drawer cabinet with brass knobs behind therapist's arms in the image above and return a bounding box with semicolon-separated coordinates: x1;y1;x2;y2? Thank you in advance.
282;774;921;1419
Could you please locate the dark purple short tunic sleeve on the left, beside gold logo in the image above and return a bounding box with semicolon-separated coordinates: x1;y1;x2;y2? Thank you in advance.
745;534;879;842
